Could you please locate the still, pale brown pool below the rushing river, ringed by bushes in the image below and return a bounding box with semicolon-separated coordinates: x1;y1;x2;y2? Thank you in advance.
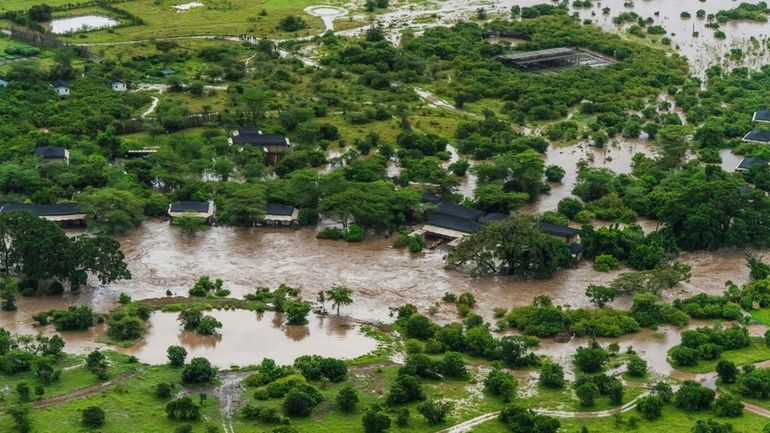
118;310;377;368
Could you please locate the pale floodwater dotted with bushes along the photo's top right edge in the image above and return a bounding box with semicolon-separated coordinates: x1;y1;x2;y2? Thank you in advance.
341;0;770;75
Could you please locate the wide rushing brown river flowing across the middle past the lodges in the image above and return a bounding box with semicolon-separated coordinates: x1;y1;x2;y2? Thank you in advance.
7;220;736;326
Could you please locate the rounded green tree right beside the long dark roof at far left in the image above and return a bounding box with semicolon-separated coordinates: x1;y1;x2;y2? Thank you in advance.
77;188;144;233
